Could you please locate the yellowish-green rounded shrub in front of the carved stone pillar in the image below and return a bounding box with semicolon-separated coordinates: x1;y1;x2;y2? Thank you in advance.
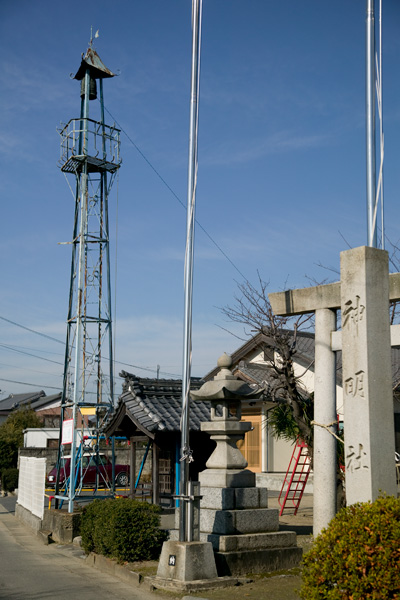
300;496;400;600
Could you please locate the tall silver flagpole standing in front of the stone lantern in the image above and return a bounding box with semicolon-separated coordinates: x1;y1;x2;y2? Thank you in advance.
179;0;202;542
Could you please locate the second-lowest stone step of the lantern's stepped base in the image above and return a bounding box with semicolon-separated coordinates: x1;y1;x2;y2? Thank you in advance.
200;531;296;552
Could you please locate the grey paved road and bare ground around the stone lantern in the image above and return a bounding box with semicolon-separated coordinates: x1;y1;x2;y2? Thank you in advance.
0;492;313;600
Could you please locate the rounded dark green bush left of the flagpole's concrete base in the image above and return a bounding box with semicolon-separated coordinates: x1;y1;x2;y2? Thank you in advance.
81;498;168;562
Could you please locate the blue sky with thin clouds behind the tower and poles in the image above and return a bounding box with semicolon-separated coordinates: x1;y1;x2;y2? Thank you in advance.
0;0;400;397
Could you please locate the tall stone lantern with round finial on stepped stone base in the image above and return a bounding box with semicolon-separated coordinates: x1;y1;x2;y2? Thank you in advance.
191;354;302;576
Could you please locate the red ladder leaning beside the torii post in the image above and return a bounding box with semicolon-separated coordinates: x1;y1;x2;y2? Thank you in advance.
278;439;311;516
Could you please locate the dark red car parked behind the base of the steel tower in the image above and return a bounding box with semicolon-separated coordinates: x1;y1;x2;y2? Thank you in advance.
46;453;129;487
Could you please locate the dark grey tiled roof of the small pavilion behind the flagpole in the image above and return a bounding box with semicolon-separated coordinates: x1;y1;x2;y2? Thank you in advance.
106;371;210;433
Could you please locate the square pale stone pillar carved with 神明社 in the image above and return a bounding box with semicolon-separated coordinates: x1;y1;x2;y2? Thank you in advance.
340;246;396;504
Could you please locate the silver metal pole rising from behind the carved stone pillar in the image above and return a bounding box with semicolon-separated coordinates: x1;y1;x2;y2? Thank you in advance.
365;0;377;248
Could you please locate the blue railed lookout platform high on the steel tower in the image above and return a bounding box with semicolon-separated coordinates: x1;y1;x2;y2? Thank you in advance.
58;118;122;173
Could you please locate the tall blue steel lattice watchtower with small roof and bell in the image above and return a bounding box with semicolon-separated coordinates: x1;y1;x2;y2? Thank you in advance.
56;41;121;512
